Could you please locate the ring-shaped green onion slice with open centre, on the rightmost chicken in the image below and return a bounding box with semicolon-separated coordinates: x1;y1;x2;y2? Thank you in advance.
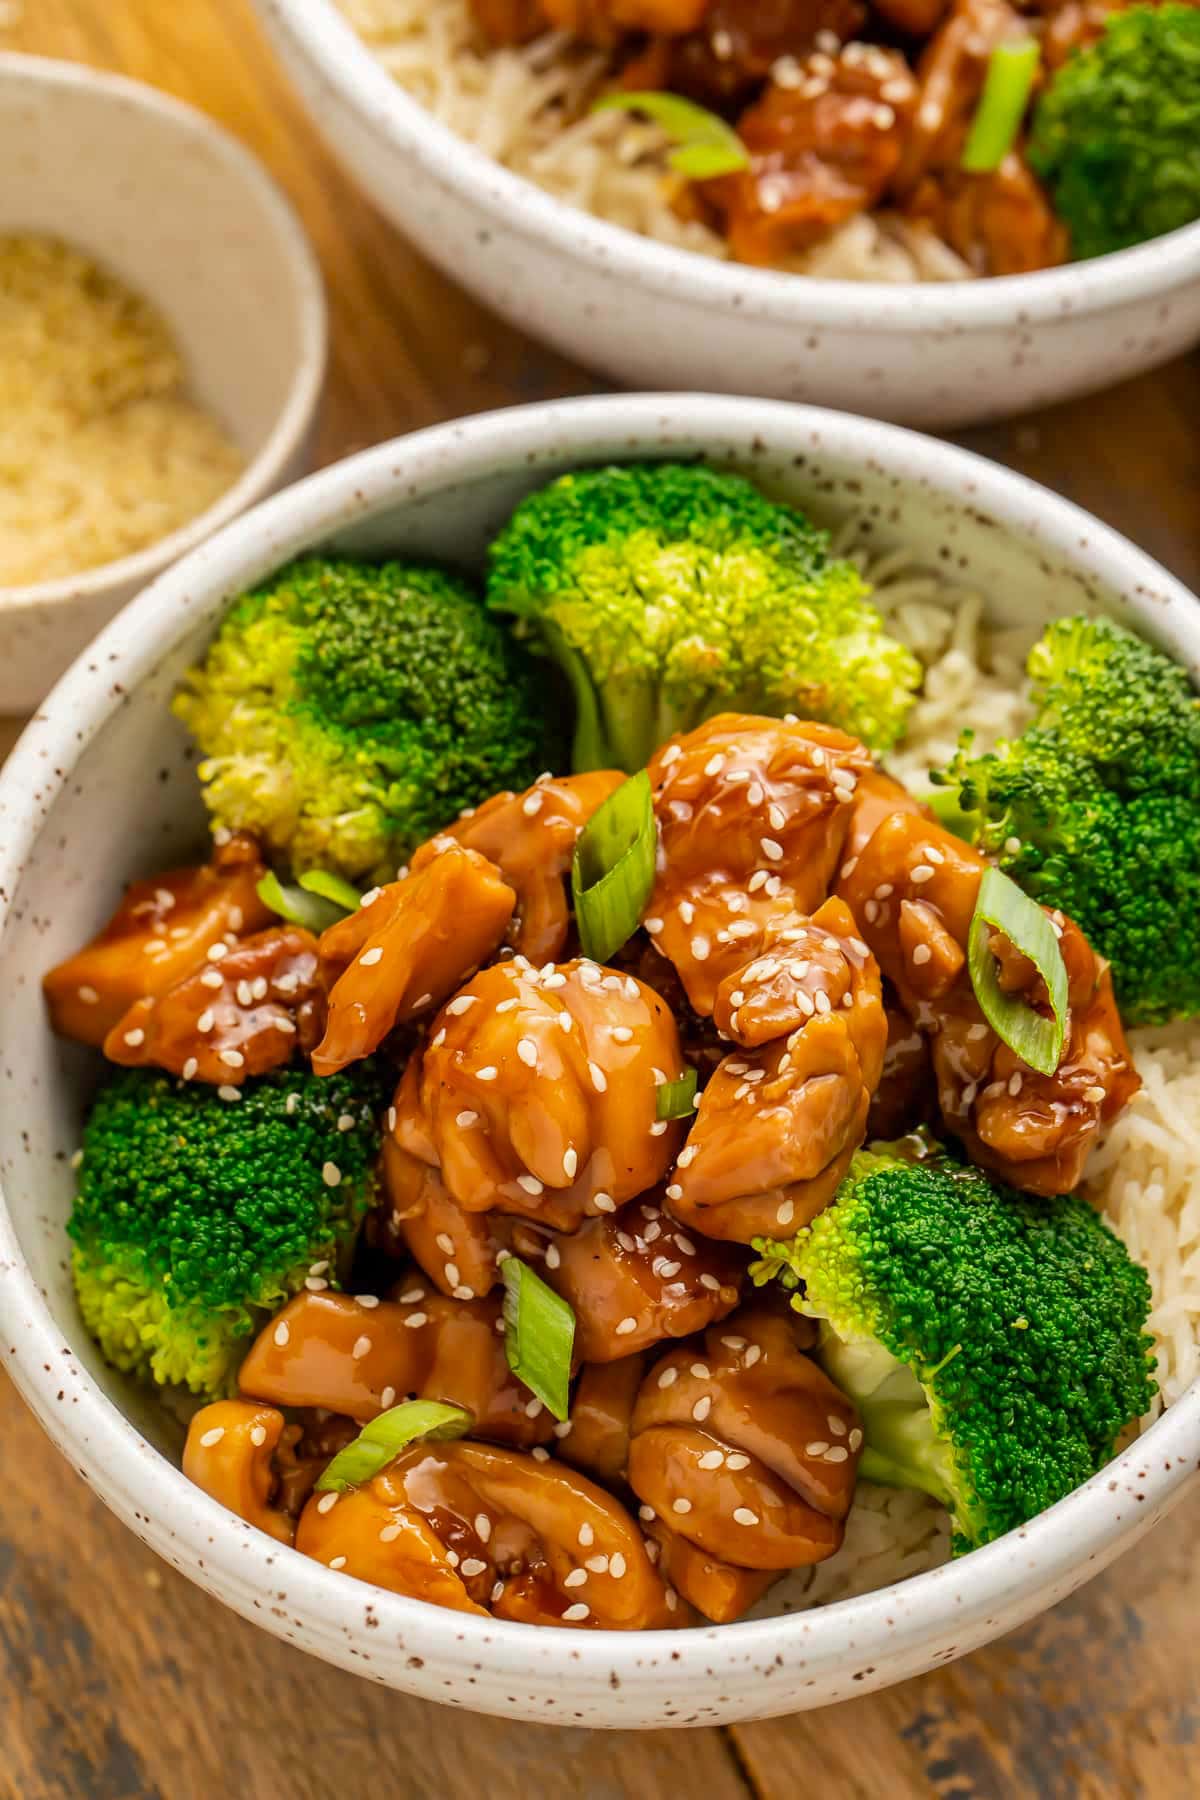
968;868;1067;1075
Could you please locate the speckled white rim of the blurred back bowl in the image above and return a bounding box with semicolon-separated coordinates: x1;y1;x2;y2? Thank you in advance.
252;0;1200;337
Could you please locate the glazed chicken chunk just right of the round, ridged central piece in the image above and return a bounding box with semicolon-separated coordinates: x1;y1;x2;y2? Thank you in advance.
666;900;887;1244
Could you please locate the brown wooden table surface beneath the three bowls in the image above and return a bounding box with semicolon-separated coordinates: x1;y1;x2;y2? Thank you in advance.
0;0;1200;1800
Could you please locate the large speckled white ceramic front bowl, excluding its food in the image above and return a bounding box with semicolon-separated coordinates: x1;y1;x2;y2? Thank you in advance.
0;396;1200;1726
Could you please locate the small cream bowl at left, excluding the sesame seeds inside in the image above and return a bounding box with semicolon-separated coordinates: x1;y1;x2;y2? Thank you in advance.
0;54;326;713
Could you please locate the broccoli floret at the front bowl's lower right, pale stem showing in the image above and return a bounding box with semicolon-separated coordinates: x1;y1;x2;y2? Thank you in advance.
752;1139;1155;1550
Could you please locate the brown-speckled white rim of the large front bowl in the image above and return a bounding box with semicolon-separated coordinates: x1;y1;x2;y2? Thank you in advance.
0;394;1200;1699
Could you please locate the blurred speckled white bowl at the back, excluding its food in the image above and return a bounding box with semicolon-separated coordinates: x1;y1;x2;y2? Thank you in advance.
246;0;1200;427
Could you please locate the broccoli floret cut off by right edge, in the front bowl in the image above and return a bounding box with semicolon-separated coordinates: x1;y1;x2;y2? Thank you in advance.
930;617;1200;1024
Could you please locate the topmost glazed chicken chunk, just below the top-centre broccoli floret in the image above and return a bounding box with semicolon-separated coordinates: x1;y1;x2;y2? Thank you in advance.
644;713;871;1013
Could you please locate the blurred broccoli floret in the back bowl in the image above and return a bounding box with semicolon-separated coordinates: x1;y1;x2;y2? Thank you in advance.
1027;5;1200;257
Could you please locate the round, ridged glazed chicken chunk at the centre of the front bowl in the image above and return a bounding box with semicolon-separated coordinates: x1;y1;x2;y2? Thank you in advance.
396;958;684;1228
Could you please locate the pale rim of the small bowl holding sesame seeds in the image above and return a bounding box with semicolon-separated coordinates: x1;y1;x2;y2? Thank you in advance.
0;50;329;616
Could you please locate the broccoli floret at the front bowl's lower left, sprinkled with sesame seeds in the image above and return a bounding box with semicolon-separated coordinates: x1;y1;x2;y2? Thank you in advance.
67;1062;383;1399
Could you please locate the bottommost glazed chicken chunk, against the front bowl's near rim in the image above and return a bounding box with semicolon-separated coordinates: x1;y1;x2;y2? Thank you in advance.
295;1442;682;1631
